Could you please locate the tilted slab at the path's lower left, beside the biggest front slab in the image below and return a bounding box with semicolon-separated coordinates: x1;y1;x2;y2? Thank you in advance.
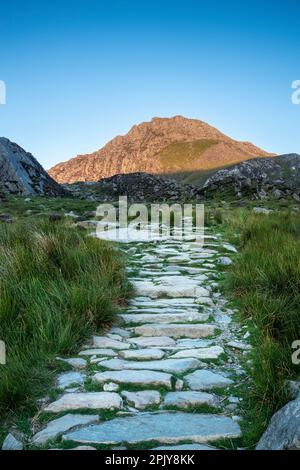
32;414;99;445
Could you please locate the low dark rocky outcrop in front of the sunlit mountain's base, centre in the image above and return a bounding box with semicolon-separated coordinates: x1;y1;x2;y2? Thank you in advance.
64;173;200;201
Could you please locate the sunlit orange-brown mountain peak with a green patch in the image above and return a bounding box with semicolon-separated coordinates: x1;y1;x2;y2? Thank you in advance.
49;116;271;183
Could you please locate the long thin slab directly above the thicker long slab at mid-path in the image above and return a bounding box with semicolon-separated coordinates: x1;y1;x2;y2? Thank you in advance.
120;311;209;324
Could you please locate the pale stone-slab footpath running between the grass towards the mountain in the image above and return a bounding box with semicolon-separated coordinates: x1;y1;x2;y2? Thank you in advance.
30;229;250;450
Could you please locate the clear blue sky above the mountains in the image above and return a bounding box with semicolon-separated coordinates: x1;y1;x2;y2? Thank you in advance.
0;0;300;168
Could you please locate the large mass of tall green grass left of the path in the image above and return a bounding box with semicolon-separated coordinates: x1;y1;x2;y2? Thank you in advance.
0;221;130;416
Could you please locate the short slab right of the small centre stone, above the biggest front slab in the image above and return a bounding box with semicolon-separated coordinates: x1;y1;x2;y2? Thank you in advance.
163;391;219;408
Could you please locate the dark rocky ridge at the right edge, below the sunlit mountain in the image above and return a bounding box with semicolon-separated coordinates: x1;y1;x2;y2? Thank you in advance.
202;153;300;201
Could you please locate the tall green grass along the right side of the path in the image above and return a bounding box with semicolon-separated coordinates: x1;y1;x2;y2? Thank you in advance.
225;212;300;446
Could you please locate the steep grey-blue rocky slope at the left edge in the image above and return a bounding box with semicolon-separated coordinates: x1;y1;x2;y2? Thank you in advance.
0;137;66;196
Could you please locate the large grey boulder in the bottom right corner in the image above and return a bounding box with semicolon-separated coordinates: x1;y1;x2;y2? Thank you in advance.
256;398;300;450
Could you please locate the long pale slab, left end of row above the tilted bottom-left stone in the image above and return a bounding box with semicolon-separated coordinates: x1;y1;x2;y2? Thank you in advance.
44;392;122;413
